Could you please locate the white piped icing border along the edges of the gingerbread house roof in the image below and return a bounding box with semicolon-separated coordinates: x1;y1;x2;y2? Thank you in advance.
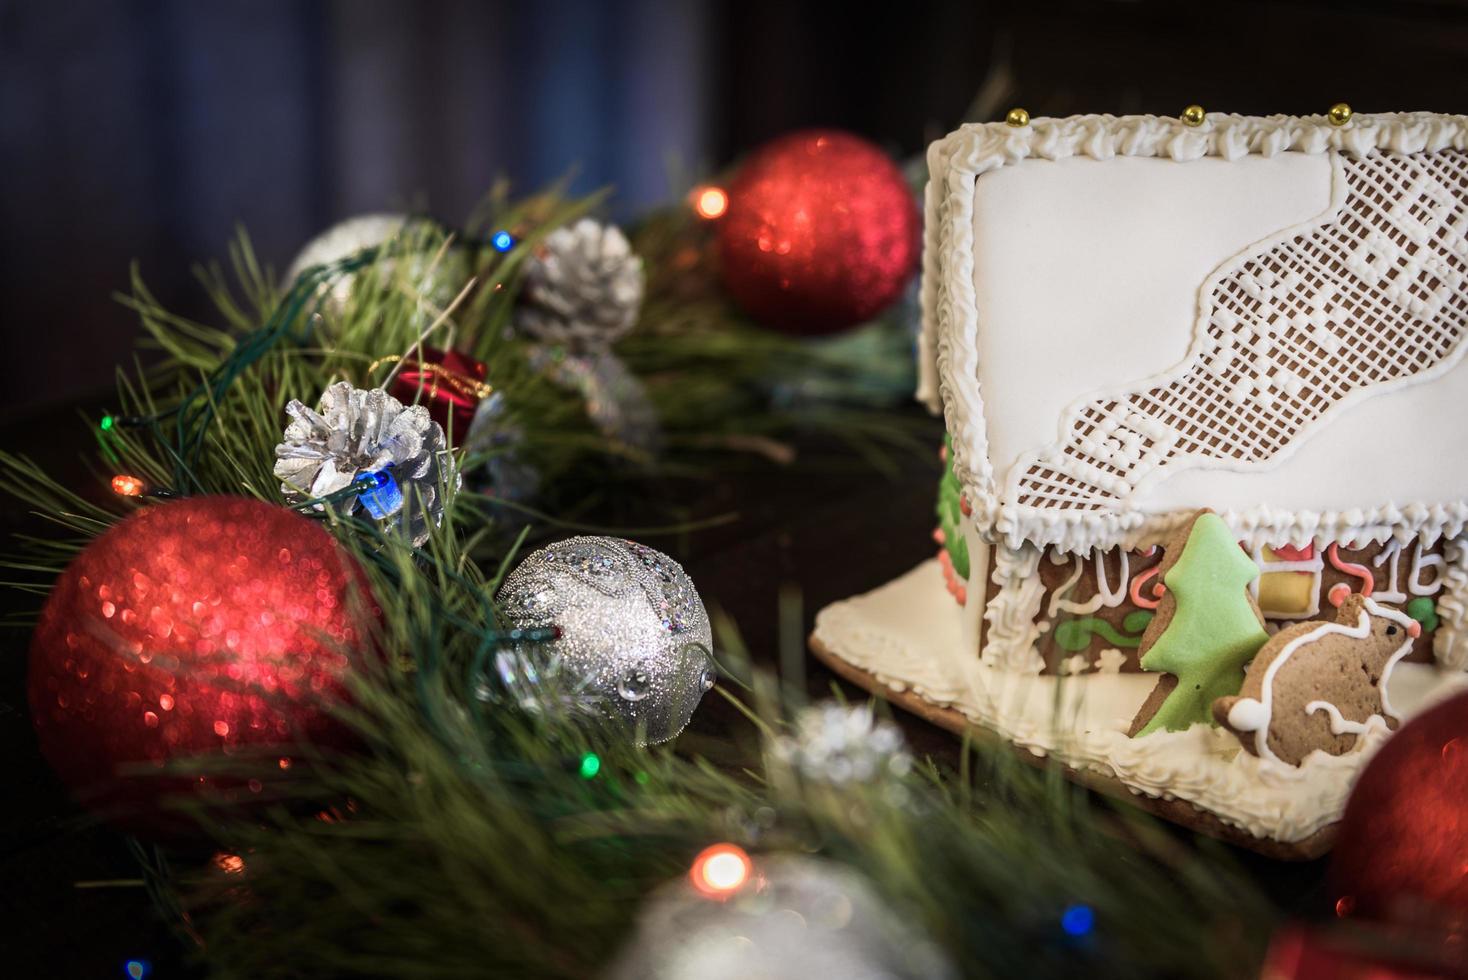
918;113;1468;552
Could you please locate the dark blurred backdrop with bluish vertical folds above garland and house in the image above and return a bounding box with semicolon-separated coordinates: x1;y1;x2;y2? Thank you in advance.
0;0;1468;412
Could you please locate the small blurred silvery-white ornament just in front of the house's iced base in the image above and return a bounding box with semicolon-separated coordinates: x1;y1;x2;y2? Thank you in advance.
775;701;913;785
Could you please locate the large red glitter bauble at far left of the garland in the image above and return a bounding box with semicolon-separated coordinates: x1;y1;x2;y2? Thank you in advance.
29;497;377;827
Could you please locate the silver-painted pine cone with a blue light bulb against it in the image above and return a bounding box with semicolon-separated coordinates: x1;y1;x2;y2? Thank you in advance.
275;381;462;544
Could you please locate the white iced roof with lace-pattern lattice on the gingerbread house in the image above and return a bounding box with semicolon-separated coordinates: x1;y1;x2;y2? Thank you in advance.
919;114;1468;550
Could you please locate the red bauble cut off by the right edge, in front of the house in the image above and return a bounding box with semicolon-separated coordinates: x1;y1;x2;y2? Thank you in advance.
1331;694;1468;932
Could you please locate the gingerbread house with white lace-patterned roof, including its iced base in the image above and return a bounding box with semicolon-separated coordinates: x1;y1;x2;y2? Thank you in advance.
813;107;1468;855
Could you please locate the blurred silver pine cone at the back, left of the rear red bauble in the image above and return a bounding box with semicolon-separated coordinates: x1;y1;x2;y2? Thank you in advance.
515;217;643;347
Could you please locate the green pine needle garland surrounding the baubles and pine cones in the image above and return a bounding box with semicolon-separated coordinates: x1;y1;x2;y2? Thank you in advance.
0;186;1274;979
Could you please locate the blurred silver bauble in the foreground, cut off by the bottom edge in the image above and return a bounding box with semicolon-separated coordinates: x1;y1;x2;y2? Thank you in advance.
608;857;957;980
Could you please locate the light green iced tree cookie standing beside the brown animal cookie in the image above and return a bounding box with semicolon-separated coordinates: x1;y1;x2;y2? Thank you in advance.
1129;511;1270;735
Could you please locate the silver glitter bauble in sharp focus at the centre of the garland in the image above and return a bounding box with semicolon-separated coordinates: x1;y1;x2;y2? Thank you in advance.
499;537;716;742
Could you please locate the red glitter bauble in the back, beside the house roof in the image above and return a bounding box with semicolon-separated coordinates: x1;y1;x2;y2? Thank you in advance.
719;131;919;334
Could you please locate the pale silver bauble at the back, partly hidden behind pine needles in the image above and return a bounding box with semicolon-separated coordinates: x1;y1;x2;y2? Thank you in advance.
280;213;470;317
